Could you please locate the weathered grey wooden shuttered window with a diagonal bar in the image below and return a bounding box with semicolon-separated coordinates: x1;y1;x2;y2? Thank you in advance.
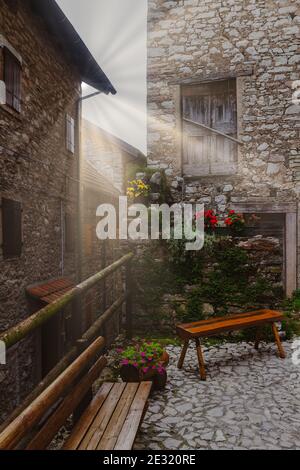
182;79;238;176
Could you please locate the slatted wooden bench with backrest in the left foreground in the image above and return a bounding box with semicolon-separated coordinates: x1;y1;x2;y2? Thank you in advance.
0;338;152;450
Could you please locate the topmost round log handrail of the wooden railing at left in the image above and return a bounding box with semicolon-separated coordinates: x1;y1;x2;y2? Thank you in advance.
0;253;133;348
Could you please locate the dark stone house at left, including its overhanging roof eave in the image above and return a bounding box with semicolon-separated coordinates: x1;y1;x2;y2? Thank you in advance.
0;0;116;420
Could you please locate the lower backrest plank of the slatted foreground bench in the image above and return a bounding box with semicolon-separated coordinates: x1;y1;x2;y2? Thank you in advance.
27;357;107;450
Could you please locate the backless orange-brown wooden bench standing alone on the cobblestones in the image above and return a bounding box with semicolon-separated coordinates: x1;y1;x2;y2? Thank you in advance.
176;310;286;380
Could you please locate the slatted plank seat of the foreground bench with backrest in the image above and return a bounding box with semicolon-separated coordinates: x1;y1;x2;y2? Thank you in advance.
64;382;152;450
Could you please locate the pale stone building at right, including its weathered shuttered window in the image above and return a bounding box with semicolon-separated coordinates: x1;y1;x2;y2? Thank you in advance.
148;0;300;294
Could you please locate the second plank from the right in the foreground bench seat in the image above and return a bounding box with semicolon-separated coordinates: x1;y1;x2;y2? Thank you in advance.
97;383;139;450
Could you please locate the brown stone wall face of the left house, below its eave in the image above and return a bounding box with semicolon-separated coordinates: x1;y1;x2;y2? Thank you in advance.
0;0;81;420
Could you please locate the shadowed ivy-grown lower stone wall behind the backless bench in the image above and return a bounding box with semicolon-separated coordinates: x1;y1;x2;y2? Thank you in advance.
131;233;284;337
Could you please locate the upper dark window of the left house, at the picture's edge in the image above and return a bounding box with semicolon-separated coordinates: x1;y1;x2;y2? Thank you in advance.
4;47;21;113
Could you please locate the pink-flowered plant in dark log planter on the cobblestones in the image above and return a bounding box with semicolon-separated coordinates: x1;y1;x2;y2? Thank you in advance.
118;341;169;390
